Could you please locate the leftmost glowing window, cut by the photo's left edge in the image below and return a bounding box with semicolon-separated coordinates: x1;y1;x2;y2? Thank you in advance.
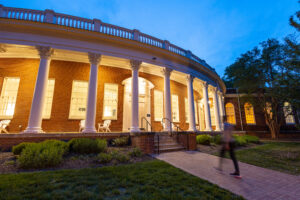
0;77;20;119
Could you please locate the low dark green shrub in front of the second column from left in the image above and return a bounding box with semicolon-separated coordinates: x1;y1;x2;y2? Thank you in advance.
68;138;107;154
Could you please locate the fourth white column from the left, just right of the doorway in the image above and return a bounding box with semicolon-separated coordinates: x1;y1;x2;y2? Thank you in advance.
162;67;172;131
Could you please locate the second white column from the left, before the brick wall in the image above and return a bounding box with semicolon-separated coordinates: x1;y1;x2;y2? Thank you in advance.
82;53;101;133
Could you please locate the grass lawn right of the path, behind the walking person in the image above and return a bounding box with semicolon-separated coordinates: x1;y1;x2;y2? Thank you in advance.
236;142;300;175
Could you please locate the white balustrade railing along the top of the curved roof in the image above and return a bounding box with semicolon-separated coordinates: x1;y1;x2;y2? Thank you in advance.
0;5;215;72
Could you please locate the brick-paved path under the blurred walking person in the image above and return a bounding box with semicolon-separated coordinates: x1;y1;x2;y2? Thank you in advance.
155;151;300;200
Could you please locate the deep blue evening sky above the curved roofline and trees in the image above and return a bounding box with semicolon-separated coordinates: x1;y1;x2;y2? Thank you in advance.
0;0;300;76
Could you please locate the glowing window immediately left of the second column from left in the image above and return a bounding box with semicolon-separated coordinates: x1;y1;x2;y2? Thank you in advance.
69;81;88;119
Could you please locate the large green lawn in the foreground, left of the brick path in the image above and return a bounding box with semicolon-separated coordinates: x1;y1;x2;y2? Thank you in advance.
0;160;242;200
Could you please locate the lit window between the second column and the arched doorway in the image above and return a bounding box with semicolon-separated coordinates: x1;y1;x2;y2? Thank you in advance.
103;83;118;120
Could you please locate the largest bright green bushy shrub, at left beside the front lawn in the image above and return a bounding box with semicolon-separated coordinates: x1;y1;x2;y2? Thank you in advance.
18;140;68;169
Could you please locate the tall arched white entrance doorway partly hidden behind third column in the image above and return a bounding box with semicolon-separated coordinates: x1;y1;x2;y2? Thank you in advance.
122;77;154;132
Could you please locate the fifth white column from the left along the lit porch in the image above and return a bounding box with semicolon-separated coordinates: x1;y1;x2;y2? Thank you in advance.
186;75;197;132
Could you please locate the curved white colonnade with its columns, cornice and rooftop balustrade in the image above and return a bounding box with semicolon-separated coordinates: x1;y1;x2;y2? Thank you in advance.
0;5;226;133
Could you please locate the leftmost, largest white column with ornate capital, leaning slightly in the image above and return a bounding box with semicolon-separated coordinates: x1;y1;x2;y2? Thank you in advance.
24;46;53;133
